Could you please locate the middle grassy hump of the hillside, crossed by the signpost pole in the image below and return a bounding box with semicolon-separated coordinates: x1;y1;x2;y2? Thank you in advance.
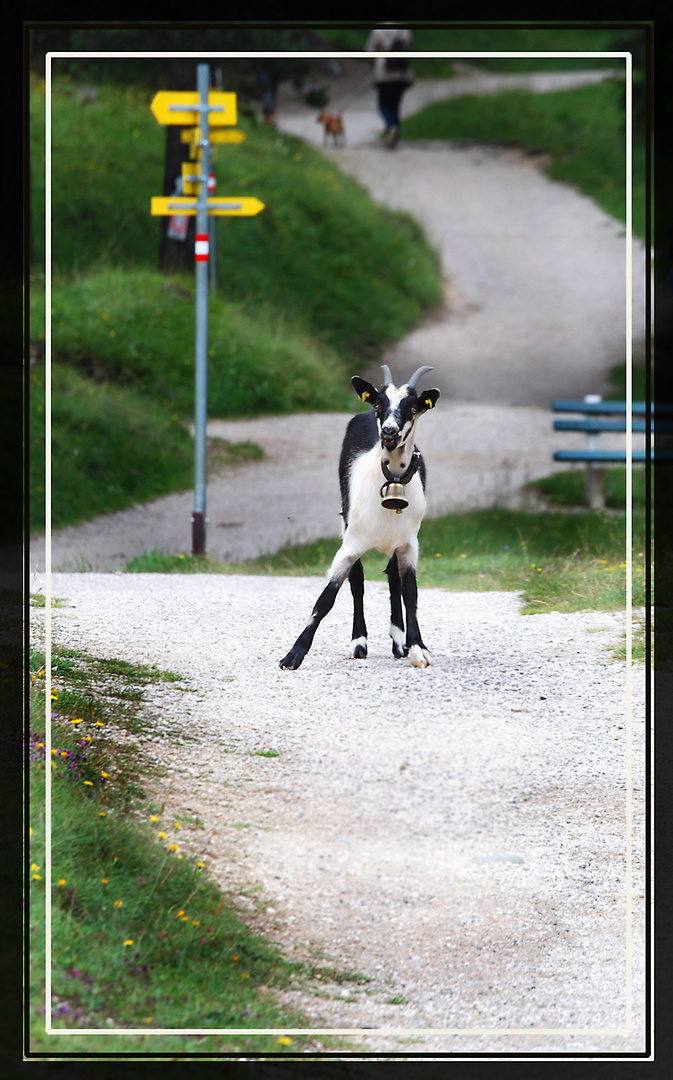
31;269;352;418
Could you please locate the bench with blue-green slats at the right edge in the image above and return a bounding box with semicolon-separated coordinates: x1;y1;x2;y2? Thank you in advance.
552;394;652;510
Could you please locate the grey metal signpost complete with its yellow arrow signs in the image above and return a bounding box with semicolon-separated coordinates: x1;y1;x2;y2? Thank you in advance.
150;64;264;555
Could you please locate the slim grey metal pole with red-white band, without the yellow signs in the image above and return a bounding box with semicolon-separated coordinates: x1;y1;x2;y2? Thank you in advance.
191;64;211;555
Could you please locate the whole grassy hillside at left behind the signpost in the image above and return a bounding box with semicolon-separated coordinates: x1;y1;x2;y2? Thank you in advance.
30;80;441;529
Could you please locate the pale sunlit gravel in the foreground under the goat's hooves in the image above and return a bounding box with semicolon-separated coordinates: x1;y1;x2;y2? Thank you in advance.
32;573;644;1054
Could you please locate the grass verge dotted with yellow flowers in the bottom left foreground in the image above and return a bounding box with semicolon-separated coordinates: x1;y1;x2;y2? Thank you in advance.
28;650;356;1055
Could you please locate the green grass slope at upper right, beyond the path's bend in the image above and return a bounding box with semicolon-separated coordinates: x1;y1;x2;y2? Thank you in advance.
402;81;645;240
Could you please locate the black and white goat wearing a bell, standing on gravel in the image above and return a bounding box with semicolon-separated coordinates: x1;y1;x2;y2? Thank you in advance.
280;364;440;670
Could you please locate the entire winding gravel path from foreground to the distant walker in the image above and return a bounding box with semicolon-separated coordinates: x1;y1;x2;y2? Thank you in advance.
31;65;645;1056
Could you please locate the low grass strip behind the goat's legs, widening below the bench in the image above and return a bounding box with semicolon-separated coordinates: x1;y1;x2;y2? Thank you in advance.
125;510;645;613
